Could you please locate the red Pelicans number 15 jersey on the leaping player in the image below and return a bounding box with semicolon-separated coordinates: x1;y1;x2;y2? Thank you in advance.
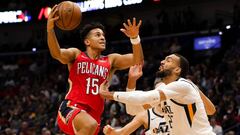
66;52;111;112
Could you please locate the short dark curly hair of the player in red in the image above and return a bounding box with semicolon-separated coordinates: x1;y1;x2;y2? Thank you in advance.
80;22;106;44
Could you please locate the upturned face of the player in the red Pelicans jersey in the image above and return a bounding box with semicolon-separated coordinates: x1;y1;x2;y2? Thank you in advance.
85;28;106;51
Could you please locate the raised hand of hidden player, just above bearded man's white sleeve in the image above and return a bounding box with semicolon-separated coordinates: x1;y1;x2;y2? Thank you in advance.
128;64;143;80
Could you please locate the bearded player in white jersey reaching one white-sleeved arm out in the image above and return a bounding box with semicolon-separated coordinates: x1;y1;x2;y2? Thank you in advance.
100;54;215;135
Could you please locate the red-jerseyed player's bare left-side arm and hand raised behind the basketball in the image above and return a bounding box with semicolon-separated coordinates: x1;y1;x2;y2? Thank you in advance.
47;5;79;64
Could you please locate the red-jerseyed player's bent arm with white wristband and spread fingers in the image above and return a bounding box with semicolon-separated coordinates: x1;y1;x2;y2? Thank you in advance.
109;18;144;70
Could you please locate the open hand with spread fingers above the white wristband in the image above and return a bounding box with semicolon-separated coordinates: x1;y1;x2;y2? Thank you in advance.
120;17;142;39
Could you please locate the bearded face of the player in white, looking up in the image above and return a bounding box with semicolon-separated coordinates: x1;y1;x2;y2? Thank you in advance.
157;54;180;77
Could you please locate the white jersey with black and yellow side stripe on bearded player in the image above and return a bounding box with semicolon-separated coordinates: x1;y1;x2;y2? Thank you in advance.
157;78;215;135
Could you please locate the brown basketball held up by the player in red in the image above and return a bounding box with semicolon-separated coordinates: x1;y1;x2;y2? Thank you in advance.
55;1;82;30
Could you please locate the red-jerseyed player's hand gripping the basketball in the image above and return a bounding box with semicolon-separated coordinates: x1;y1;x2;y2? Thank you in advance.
47;5;59;31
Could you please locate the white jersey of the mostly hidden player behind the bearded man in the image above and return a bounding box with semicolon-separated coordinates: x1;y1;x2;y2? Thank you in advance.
145;108;171;135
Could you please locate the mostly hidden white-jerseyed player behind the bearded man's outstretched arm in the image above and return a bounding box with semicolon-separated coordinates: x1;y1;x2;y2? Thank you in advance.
103;65;171;135
